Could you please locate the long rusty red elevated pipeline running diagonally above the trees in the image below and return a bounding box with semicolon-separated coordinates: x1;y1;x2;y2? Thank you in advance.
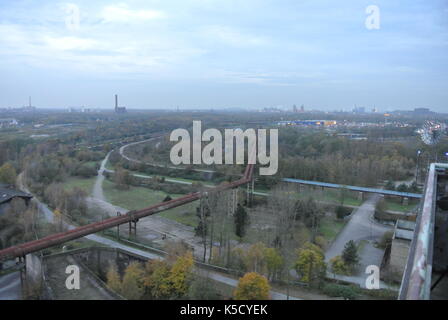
0;164;254;262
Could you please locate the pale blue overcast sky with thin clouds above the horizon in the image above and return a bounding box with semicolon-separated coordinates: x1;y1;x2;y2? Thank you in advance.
0;0;448;112
